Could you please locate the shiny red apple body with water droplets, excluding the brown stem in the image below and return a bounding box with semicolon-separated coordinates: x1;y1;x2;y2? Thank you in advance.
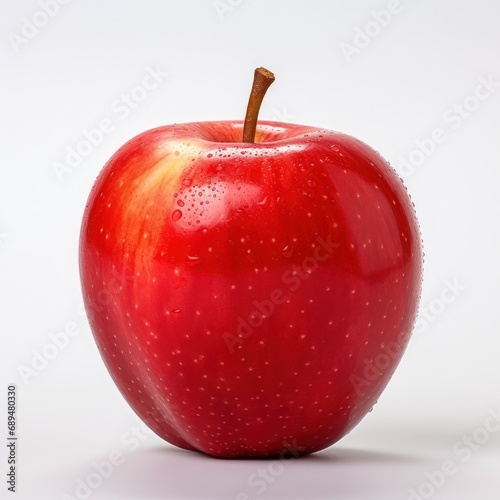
80;121;422;458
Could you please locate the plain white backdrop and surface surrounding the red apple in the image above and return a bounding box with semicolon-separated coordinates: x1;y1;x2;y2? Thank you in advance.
0;0;500;500
